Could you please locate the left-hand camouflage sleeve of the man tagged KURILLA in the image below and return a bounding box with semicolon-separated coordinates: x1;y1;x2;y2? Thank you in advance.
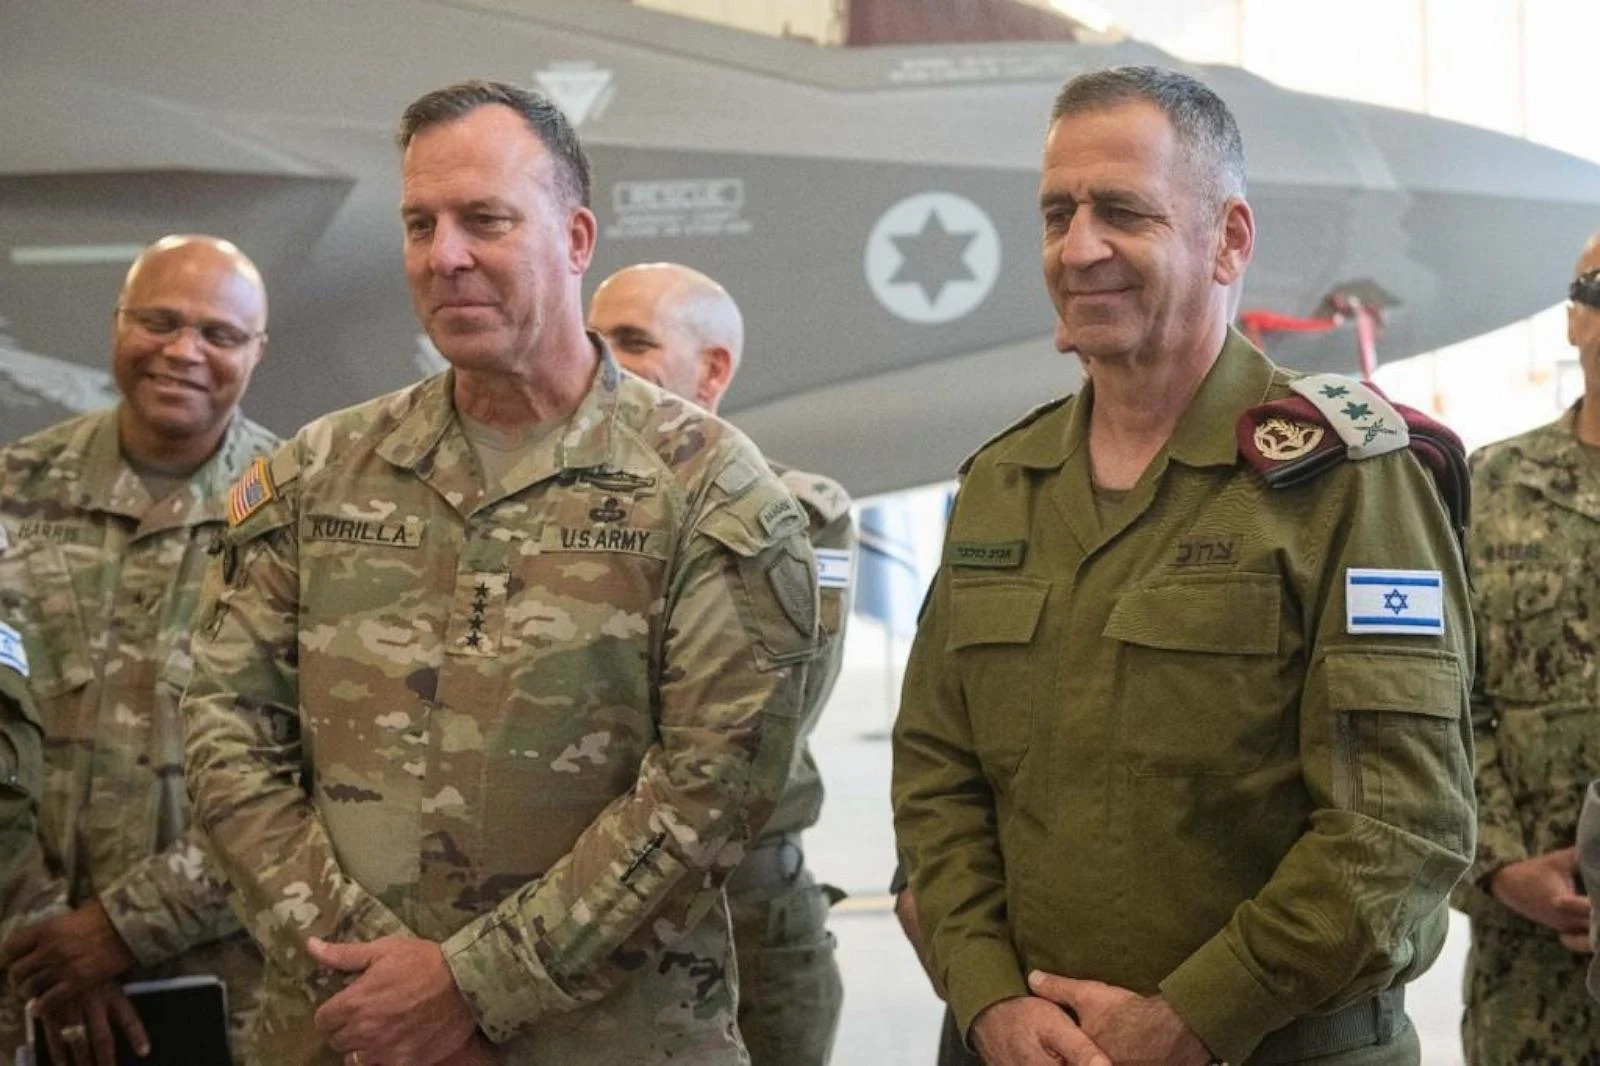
182;453;410;999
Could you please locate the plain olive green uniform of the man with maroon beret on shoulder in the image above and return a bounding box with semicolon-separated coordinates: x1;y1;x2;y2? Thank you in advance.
893;335;1474;1063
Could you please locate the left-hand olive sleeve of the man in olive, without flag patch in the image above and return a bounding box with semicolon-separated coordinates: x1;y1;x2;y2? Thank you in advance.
893;547;1029;1034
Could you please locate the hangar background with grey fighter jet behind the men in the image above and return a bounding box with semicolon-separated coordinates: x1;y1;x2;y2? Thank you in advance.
0;0;1600;1066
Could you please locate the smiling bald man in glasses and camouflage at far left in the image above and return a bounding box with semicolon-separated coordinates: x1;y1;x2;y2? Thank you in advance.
0;235;274;1066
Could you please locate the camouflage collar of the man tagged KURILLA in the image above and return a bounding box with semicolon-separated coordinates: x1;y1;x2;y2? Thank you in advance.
378;333;622;515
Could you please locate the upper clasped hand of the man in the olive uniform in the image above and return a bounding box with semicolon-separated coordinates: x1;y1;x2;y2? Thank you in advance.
1027;970;1211;1066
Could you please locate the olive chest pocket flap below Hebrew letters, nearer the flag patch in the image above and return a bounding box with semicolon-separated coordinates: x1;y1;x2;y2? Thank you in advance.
1104;573;1282;655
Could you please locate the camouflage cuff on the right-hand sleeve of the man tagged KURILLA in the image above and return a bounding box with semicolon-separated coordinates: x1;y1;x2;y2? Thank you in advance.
440;912;578;1044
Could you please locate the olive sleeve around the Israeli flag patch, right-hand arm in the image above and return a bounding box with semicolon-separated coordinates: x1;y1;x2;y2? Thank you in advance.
1160;451;1475;1061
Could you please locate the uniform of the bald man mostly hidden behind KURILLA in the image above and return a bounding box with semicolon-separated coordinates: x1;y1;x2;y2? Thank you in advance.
728;463;856;1066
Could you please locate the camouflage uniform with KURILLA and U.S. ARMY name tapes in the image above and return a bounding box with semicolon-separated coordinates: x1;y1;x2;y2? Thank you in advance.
184;347;818;1066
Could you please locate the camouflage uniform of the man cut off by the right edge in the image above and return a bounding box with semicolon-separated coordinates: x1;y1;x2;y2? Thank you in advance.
1454;408;1600;1066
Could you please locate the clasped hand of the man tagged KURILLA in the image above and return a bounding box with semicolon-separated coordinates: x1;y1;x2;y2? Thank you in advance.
307;936;478;1066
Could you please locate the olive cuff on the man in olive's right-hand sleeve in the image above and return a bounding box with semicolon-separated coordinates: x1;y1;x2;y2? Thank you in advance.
1162;933;1296;1063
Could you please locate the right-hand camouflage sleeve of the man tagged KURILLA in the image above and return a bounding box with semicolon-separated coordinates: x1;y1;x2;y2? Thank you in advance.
445;477;816;1042
